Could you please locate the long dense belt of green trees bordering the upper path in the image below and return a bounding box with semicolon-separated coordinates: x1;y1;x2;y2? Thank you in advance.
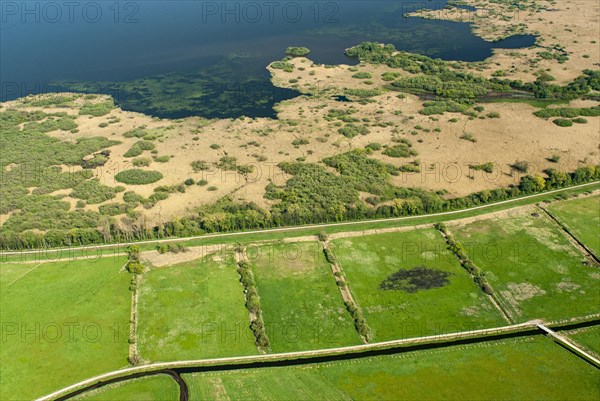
0;166;600;250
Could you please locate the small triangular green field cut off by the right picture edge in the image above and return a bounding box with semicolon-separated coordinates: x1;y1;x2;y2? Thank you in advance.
548;196;600;258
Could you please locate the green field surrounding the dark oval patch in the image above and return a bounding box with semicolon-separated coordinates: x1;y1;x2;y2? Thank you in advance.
333;229;506;341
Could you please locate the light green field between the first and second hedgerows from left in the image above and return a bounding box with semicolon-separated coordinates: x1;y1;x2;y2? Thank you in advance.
138;254;257;362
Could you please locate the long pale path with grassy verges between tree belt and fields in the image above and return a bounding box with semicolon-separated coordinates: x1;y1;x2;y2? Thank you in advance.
0;181;600;256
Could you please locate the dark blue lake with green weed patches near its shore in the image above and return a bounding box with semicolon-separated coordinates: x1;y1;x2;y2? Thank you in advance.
0;0;535;117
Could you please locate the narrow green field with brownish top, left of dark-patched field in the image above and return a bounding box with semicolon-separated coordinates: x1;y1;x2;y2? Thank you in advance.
248;242;360;352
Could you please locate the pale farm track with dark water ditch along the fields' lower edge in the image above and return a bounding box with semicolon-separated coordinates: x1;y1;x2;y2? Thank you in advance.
37;315;600;401
